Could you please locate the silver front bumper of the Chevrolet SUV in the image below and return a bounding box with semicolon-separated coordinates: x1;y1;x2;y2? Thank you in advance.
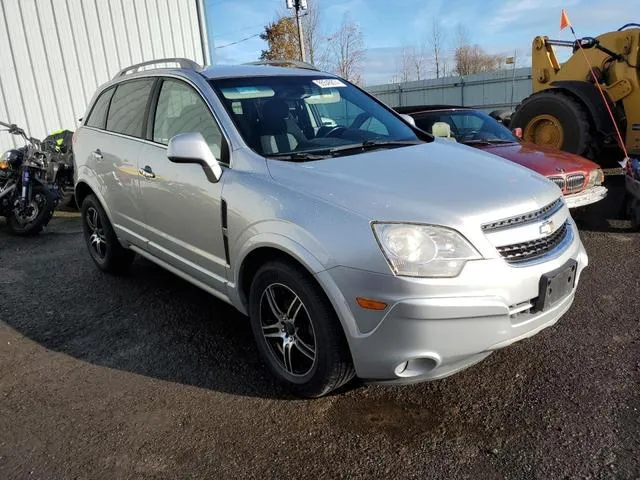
318;226;588;383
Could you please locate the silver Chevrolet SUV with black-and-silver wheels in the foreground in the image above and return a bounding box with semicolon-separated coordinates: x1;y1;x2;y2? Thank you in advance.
74;59;587;396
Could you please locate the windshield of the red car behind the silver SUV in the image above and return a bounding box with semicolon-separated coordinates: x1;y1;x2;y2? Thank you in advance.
415;110;518;144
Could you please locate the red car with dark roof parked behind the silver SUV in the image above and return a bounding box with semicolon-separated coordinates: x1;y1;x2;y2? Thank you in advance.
396;105;607;208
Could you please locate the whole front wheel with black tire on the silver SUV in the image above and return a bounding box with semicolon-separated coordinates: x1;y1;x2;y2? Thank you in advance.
249;261;355;398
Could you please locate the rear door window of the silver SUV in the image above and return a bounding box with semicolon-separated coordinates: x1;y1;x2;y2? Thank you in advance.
107;79;154;137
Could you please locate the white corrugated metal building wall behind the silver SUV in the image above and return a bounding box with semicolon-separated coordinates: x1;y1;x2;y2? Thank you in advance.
0;0;208;151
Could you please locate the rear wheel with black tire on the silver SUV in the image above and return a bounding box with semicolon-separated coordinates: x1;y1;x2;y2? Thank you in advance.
82;195;135;274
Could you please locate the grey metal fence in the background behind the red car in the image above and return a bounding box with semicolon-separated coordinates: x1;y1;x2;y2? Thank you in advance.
366;68;531;110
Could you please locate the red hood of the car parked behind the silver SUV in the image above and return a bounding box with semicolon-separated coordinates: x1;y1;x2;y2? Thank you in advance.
478;143;599;176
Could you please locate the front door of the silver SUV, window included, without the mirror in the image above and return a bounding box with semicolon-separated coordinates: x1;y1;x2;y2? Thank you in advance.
138;79;227;295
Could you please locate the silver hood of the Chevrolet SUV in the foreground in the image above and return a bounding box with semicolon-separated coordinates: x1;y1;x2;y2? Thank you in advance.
267;141;560;227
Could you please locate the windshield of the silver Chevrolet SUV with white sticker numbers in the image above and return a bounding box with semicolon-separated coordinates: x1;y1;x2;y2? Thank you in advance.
211;74;422;160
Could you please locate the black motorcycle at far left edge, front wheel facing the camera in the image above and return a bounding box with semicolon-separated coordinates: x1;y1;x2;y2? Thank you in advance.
0;122;60;235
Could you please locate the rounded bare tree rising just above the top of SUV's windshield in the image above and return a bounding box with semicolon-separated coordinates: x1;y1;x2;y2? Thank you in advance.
328;14;365;83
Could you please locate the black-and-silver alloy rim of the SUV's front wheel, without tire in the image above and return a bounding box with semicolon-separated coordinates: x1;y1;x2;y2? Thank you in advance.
260;283;317;376
